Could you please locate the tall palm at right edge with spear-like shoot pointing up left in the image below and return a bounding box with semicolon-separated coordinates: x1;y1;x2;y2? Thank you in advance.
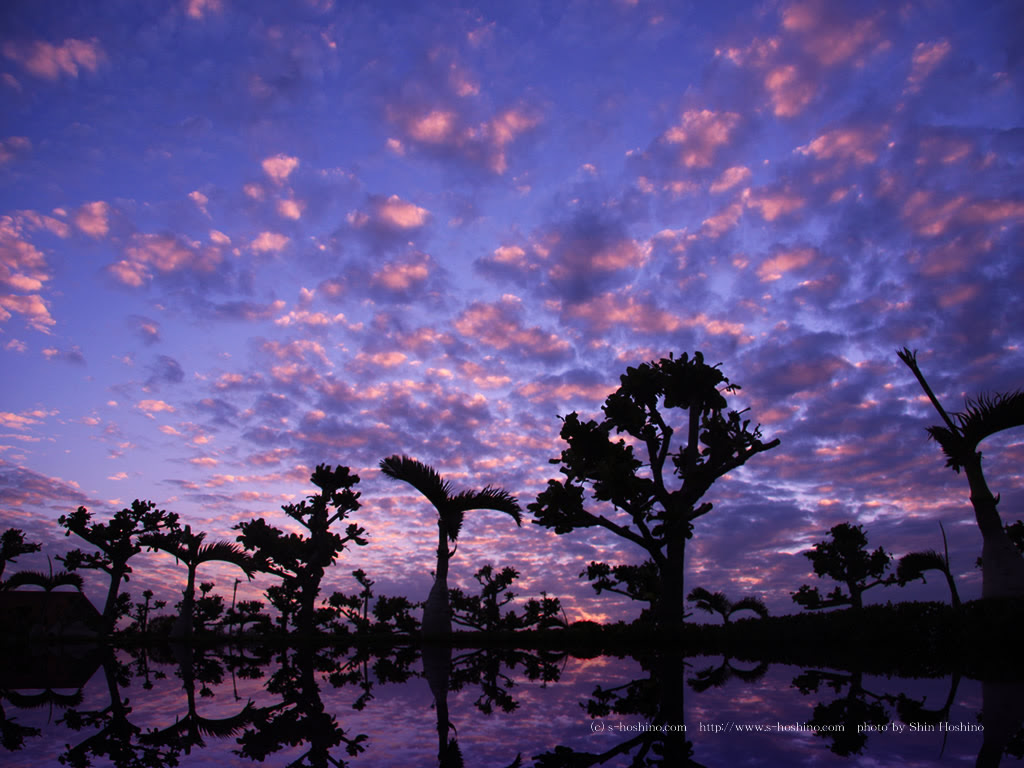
897;347;1024;598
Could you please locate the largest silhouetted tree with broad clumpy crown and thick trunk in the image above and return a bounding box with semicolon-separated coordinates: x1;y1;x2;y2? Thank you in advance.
529;352;779;628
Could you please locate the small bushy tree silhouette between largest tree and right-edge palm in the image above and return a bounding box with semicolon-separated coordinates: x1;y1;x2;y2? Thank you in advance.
791;522;892;610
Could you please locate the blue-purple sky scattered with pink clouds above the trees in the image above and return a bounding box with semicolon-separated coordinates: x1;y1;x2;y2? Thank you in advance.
0;0;1024;621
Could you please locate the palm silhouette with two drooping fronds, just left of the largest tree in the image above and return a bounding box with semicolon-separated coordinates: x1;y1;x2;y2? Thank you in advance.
380;456;522;635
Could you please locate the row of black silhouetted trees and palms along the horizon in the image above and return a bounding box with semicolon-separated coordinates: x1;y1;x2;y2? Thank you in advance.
0;349;1024;638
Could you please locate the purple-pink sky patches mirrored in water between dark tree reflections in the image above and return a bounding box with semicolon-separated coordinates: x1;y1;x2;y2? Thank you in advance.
2;650;991;768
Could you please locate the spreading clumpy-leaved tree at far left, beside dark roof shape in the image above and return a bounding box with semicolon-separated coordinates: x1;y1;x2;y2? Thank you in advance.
57;499;178;632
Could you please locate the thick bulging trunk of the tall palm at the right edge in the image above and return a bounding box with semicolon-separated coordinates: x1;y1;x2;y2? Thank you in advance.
964;453;1024;599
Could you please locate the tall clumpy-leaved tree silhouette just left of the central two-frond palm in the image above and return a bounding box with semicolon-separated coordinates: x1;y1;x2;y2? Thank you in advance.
234;464;367;634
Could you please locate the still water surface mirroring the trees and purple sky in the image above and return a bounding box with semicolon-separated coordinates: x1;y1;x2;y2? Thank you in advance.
0;645;1024;768
